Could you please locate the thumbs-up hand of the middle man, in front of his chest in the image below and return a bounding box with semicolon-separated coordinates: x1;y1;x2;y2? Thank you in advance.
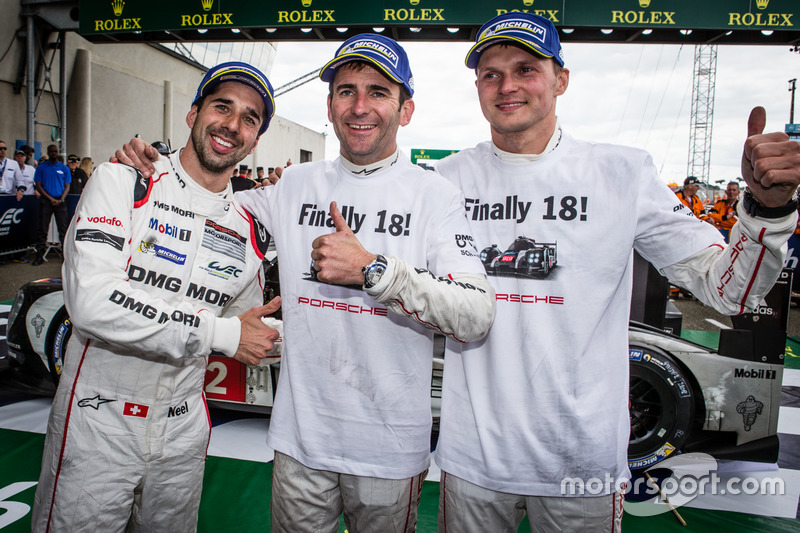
311;202;377;286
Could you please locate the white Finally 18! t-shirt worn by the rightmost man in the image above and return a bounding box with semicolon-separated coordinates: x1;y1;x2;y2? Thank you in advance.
436;131;721;496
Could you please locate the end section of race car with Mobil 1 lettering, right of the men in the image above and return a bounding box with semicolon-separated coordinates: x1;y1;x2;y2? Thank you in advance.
628;270;792;471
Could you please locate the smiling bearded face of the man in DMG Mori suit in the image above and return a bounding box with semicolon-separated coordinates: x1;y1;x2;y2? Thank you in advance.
181;82;265;179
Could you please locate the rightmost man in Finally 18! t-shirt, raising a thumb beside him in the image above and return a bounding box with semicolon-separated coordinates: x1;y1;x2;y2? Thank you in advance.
436;13;800;533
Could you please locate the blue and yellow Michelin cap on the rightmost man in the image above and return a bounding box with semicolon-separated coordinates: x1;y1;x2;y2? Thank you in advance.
466;12;564;68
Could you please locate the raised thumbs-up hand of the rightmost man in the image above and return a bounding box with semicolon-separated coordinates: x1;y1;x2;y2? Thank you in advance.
742;107;800;207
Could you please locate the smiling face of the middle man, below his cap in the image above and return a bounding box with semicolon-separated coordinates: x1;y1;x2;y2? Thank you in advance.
328;62;414;165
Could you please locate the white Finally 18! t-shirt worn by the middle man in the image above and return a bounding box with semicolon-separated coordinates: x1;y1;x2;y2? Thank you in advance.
236;156;483;479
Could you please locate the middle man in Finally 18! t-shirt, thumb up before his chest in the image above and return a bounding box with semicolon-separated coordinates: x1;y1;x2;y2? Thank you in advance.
118;34;494;533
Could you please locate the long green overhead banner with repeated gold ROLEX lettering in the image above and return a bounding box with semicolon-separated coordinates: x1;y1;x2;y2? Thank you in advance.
80;0;800;39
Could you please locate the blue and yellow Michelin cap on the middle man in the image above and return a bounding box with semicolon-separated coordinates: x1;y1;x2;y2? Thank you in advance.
319;33;414;96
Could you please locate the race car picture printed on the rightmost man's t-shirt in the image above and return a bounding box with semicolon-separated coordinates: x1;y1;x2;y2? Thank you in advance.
480;236;558;278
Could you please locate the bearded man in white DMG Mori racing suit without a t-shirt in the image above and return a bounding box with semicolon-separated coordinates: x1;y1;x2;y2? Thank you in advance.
32;62;279;532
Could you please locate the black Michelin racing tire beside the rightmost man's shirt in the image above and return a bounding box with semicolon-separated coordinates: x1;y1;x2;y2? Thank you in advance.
628;345;695;471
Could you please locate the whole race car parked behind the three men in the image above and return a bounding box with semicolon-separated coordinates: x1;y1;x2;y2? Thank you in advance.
1;270;791;471
